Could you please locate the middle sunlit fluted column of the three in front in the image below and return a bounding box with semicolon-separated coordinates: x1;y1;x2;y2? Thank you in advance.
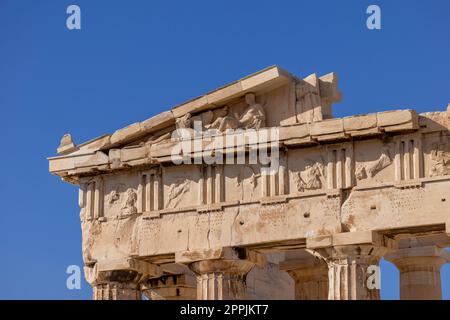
189;258;254;300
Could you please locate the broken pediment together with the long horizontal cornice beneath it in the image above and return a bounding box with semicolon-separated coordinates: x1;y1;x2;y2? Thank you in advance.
49;66;432;182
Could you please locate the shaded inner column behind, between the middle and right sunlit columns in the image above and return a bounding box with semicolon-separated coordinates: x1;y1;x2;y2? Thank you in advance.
280;253;328;300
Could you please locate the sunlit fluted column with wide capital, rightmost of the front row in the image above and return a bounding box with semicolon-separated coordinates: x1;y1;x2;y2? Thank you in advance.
314;244;386;300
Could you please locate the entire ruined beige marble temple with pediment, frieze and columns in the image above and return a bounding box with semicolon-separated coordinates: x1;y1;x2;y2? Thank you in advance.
49;66;450;300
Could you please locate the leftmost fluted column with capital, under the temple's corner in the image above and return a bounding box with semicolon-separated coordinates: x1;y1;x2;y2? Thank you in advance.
84;258;162;300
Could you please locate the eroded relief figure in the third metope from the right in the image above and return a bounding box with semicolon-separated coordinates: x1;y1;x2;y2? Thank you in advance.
294;159;325;192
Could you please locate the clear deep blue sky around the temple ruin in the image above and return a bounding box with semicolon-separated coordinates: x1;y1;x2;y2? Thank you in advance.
0;0;450;299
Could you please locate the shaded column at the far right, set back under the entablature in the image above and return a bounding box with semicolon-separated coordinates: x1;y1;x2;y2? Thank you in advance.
385;246;450;300
